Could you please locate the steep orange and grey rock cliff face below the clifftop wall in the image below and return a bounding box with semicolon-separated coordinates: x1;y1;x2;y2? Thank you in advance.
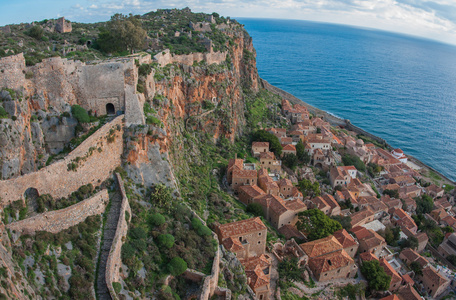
125;30;259;186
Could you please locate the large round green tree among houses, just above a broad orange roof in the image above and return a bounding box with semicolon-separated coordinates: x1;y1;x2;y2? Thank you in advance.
296;208;342;241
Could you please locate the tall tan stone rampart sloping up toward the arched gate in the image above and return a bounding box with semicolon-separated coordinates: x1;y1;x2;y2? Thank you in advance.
0;116;124;205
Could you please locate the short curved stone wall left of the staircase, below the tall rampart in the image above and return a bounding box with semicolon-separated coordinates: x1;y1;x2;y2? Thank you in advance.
7;190;109;234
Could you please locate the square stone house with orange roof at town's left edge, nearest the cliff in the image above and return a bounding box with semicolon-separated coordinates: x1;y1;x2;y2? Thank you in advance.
216;217;267;260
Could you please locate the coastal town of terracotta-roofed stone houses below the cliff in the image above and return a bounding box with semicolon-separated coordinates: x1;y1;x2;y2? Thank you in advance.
220;100;456;300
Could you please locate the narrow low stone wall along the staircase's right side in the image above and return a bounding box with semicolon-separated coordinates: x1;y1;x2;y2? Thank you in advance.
106;173;131;299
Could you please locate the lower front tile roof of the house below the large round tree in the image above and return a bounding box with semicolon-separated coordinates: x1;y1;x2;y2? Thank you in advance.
309;249;355;274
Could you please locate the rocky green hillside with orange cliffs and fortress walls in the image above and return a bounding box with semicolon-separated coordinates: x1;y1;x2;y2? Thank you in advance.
0;9;284;299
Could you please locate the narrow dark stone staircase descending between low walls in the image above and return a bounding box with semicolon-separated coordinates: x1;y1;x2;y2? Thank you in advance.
96;192;122;300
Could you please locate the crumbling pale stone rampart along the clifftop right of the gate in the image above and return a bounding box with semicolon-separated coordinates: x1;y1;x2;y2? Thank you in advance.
154;49;227;67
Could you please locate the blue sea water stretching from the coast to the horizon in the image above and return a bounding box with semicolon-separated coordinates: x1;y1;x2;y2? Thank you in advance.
238;18;456;180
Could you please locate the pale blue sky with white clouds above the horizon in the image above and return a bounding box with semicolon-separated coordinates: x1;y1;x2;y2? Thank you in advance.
0;0;456;44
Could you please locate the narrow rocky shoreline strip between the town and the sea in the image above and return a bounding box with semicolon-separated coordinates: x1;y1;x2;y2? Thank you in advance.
260;77;456;185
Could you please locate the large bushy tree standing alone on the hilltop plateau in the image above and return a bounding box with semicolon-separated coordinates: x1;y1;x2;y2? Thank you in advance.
97;14;147;53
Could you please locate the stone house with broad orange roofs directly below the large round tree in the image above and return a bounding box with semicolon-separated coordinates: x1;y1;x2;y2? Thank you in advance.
300;236;358;281
